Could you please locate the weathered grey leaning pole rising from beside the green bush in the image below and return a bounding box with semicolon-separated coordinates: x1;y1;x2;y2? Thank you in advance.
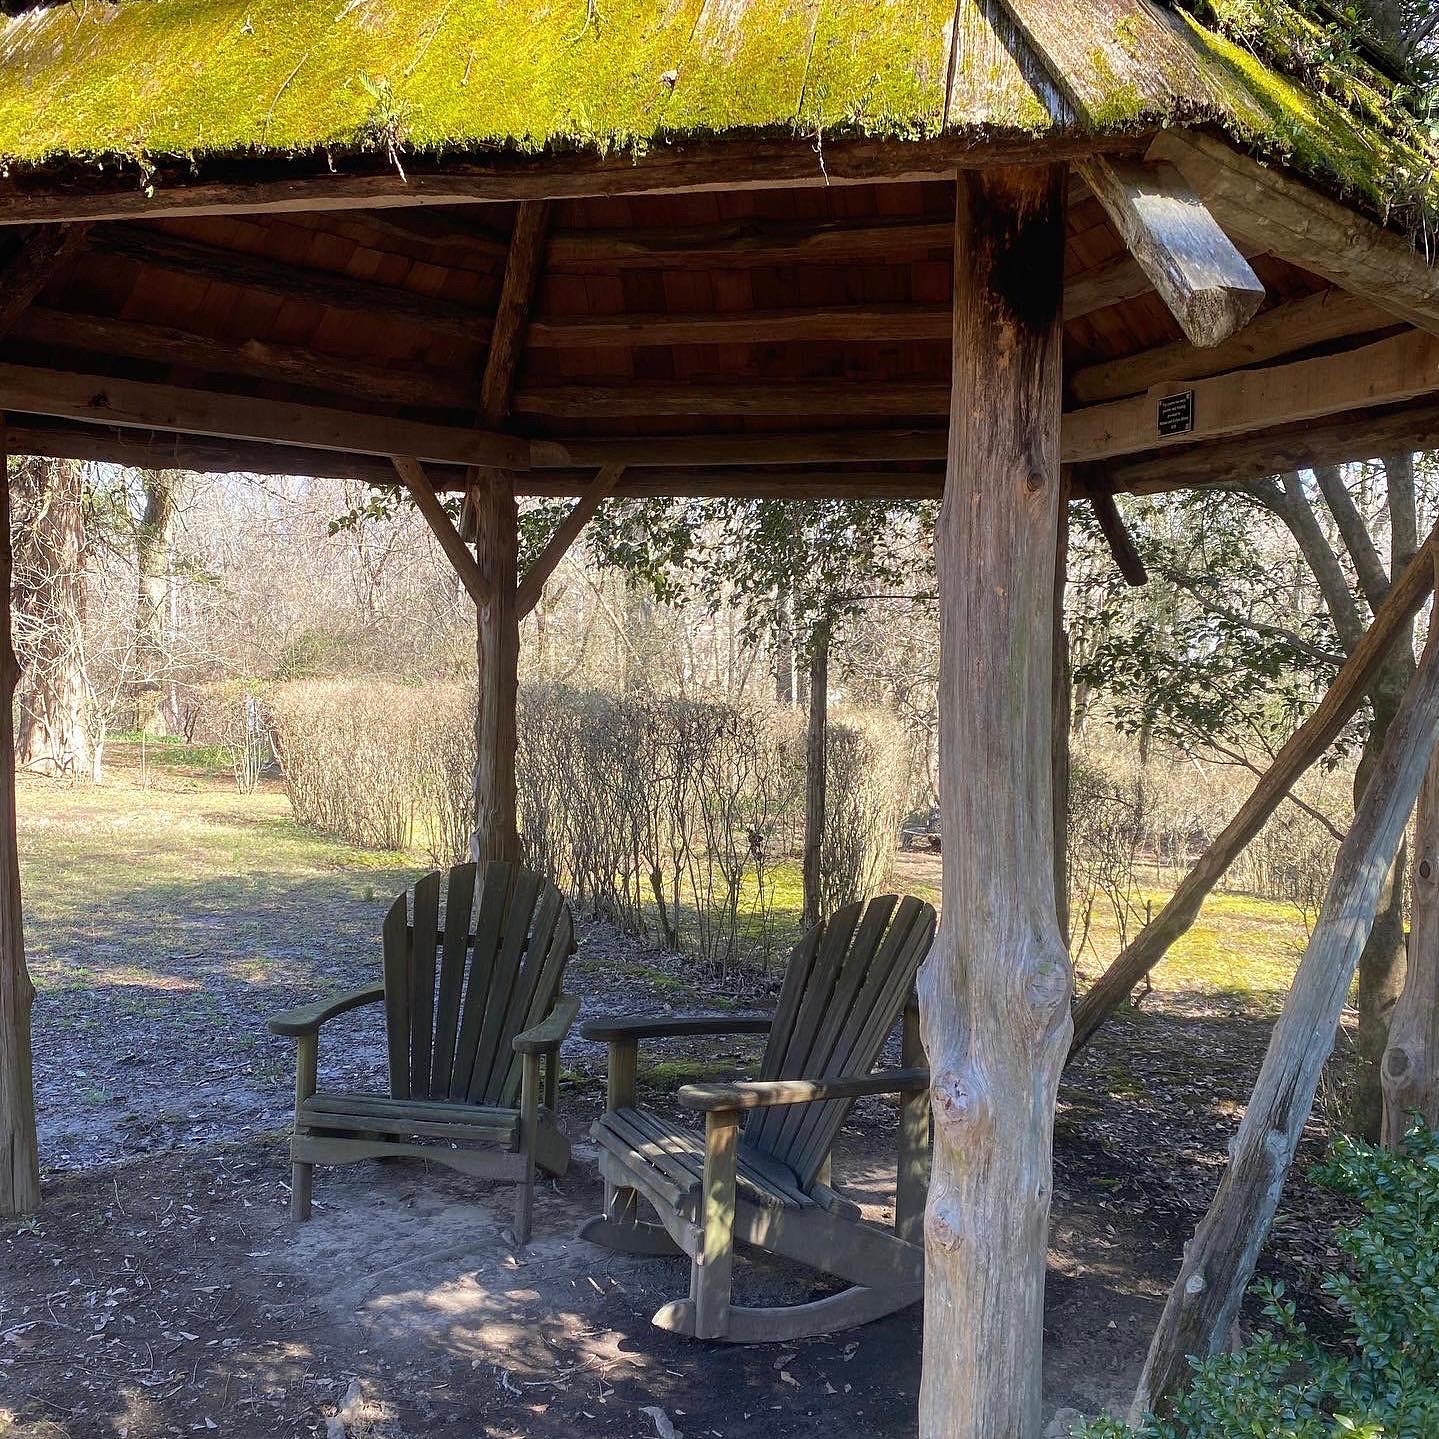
1134;592;1439;1413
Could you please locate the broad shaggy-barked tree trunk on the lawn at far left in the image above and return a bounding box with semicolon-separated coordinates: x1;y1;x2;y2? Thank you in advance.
13;459;91;774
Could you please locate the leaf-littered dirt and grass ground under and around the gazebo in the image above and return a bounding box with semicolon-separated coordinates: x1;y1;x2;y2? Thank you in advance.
0;754;1352;1439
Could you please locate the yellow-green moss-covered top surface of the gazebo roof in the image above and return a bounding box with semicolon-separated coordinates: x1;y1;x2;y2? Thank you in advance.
0;0;1435;218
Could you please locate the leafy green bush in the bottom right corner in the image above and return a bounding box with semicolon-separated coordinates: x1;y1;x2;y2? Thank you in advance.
1082;1125;1439;1439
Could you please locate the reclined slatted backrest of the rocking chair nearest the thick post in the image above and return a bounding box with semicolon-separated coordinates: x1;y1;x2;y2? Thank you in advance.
744;895;935;1189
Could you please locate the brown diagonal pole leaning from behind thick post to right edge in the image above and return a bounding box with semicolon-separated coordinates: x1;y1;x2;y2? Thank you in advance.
1069;528;1439;1059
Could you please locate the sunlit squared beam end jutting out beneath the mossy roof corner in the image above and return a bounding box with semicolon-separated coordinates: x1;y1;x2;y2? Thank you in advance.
1079;155;1263;348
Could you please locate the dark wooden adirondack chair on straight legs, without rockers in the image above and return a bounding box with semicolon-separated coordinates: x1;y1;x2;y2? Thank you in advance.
269;863;580;1243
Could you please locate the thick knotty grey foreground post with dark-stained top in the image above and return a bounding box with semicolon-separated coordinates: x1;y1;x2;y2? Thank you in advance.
920;167;1071;1439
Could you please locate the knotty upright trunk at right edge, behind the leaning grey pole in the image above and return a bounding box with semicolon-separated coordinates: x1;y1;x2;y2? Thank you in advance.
1380;755;1439;1150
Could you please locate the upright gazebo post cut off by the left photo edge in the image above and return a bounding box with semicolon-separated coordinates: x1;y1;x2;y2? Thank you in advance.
0;455;40;1215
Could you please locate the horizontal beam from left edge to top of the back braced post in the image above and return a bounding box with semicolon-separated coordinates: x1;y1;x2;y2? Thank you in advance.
0;364;530;469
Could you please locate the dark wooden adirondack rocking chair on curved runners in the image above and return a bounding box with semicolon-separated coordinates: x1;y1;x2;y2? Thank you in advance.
580;895;934;1344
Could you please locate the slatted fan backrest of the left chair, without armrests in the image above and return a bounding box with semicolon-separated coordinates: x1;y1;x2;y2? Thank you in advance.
383;862;574;1108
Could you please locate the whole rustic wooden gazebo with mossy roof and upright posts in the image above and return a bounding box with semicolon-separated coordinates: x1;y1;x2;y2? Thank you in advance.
0;0;1439;1439
